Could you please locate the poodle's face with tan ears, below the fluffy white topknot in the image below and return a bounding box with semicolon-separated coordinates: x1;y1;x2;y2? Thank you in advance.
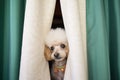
45;42;69;61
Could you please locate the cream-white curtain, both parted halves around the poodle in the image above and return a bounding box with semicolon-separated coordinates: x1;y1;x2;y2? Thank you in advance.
19;0;88;80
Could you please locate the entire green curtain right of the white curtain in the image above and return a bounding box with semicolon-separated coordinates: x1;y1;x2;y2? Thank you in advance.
86;0;120;80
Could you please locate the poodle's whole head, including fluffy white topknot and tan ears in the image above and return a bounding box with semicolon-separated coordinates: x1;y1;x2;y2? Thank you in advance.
44;28;69;61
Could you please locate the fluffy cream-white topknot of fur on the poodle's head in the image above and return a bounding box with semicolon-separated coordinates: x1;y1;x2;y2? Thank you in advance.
45;28;67;47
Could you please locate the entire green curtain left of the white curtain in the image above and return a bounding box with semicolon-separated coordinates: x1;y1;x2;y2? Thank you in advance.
0;0;25;80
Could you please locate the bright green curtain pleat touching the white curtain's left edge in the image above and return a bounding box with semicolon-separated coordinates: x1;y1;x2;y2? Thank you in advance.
9;0;25;80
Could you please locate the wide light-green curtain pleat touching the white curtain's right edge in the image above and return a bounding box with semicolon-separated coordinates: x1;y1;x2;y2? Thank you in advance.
86;0;110;80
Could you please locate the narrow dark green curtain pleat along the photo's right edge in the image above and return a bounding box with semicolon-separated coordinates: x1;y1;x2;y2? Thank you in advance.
108;0;120;80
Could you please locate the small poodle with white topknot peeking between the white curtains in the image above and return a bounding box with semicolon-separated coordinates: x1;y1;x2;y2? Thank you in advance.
44;28;69;80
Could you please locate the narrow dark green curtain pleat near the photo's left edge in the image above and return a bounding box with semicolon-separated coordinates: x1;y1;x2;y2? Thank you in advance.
1;0;10;80
